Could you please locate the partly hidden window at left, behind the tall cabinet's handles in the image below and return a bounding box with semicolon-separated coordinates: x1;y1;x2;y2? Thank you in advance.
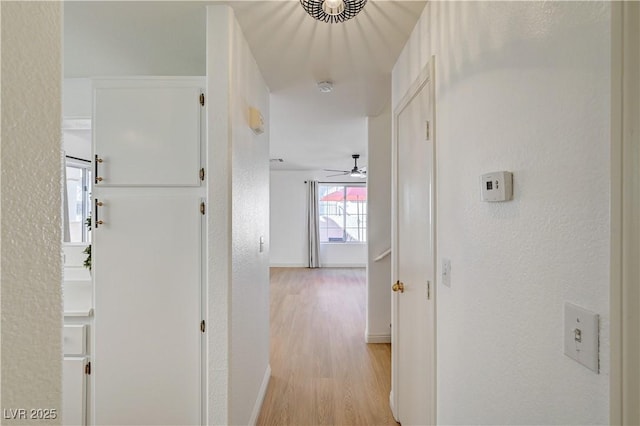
66;157;91;243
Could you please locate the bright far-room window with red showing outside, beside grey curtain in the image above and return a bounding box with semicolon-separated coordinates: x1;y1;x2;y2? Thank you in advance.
318;184;367;243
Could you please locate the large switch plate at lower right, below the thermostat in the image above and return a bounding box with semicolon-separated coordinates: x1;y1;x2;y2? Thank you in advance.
564;302;600;373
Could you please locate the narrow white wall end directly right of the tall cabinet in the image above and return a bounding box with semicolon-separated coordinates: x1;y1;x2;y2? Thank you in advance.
206;10;232;425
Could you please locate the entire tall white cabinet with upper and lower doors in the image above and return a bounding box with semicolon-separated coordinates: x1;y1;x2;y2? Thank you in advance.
91;79;205;425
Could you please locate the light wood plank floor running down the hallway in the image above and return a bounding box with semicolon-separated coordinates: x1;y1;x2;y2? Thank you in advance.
257;268;397;425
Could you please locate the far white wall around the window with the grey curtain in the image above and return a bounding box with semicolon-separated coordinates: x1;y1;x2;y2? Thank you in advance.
270;170;367;268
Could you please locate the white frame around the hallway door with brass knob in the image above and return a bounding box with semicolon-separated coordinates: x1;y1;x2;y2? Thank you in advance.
389;56;438;424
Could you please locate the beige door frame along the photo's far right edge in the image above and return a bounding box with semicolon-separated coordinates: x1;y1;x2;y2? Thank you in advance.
609;2;640;425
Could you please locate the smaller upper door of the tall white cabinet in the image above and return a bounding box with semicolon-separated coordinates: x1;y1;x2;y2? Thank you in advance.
93;84;202;186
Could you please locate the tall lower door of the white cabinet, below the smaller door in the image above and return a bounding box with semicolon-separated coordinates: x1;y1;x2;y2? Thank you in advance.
92;194;202;425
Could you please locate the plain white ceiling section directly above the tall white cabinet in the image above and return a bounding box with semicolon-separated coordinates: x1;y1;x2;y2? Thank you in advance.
63;1;206;78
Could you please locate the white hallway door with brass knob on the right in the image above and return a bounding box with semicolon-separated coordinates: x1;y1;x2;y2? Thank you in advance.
392;69;435;425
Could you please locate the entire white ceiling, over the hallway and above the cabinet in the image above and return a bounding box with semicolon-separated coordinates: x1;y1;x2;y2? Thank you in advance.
64;0;425;170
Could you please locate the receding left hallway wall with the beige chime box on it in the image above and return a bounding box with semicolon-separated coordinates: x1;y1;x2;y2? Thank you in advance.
229;14;269;424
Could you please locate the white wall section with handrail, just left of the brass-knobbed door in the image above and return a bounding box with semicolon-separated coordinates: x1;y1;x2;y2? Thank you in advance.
365;105;391;343
